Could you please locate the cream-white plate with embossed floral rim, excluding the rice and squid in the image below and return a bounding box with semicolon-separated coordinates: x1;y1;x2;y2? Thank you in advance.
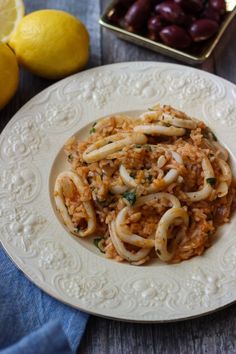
0;62;236;322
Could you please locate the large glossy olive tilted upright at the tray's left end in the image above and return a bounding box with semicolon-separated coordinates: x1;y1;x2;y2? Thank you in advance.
125;0;151;31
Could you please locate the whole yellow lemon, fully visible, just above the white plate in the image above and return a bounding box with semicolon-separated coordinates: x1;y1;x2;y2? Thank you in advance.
9;10;89;79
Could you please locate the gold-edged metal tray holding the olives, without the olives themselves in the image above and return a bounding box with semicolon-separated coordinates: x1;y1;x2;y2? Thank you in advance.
99;0;236;65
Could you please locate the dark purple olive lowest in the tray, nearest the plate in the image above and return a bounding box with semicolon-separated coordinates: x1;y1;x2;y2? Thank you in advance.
160;25;192;48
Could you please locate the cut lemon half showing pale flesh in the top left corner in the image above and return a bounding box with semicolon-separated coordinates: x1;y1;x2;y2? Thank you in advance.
0;0;25;42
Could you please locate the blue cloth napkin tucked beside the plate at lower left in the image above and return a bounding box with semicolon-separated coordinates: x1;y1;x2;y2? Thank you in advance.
0;246;88;354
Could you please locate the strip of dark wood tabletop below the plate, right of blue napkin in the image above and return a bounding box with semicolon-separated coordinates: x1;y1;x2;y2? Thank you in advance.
78;305;236;354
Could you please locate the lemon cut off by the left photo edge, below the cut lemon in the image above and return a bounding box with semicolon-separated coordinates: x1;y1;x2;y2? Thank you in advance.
0;42;19;109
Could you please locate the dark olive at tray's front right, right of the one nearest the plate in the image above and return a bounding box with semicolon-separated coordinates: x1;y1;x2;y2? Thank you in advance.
189;18;218;42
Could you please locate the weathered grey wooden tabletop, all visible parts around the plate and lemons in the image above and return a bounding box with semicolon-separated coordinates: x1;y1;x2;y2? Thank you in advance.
0;0;236;354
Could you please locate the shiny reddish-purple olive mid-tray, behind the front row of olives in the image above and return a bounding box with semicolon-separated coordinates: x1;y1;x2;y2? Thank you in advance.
155;1;186;24
